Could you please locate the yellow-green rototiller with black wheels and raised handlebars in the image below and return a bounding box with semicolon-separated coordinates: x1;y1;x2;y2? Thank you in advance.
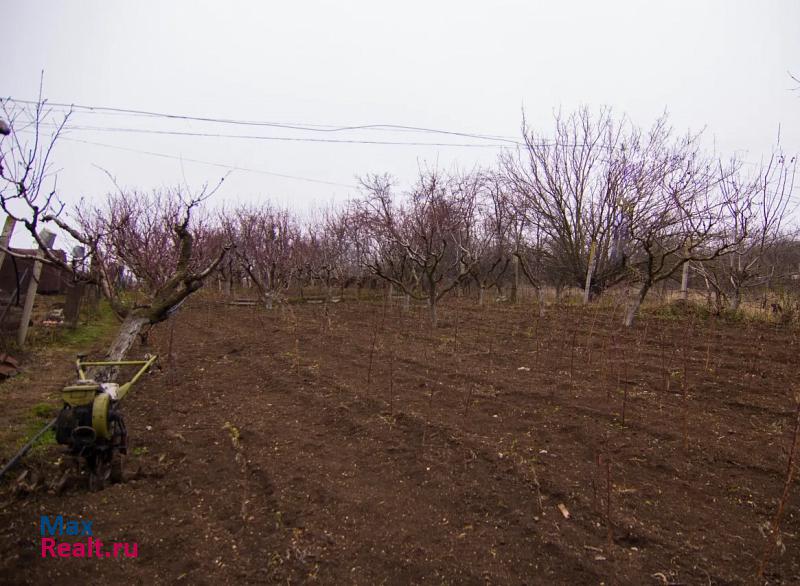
55;356;158;490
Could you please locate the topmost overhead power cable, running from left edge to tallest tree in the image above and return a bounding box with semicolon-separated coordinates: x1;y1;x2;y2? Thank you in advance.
7;98;522;145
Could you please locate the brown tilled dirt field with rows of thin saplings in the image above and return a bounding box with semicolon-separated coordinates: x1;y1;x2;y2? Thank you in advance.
0;299;800;585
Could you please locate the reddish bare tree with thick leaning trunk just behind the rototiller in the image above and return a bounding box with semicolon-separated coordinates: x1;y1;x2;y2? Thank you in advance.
76;183;229;359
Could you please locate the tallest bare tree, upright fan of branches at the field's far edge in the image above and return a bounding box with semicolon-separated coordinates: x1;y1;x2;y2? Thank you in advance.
500;109;636;297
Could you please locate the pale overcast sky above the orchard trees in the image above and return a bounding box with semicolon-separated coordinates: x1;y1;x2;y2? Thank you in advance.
0;0;800;225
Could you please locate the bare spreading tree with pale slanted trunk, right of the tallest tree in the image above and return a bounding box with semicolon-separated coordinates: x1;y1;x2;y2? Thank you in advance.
616;132;745;326
